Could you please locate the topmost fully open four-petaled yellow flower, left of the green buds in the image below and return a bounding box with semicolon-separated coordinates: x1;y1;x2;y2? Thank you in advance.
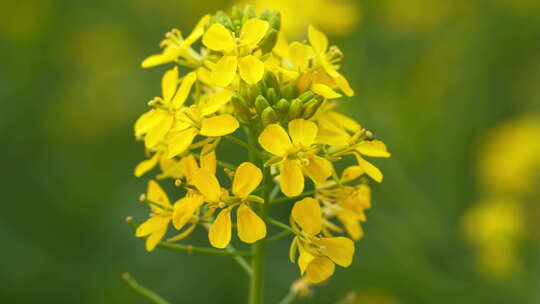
202;18;269;87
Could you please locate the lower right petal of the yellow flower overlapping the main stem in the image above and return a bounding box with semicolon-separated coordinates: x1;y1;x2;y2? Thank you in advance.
236;204;266;244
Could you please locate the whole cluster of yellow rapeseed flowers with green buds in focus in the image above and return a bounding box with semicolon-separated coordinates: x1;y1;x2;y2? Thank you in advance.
127;7;390;303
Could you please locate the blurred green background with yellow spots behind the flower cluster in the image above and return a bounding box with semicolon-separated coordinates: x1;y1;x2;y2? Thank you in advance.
0;0;540;304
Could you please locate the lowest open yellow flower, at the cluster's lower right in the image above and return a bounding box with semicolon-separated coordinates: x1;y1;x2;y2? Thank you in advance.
291;197;354;283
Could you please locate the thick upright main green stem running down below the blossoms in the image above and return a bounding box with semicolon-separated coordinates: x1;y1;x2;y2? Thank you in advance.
247;126;272;304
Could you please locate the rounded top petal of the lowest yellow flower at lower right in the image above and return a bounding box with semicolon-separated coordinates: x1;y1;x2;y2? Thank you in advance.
291;197;322;235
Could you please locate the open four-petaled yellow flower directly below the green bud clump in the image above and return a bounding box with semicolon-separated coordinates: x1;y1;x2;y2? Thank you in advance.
259;119;333;197
